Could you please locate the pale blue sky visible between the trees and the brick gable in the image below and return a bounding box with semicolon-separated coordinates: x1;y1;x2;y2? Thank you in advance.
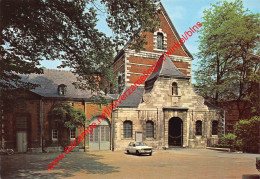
41;0;260;80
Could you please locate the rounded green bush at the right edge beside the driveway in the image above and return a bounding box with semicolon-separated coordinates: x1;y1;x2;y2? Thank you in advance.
234;116;260;153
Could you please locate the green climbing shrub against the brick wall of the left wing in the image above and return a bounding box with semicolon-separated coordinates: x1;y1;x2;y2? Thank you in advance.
49;102;86;130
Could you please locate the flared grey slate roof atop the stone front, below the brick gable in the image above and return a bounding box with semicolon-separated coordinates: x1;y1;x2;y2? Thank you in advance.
146;56;189;82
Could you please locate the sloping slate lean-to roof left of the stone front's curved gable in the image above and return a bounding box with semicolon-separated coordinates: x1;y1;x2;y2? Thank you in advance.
118;87;144;108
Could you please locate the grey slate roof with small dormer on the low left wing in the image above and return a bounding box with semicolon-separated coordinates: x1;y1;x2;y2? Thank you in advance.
21;69;107;99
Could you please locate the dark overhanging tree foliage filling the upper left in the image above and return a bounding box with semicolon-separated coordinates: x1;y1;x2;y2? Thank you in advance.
0;0;158;91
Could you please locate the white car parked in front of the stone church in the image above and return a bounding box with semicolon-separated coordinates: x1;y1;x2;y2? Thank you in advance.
126;142;153;155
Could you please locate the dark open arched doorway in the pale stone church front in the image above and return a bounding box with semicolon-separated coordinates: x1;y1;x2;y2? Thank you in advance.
168;117;183;147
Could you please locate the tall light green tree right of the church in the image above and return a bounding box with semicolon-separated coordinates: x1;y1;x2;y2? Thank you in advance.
195;0;260;117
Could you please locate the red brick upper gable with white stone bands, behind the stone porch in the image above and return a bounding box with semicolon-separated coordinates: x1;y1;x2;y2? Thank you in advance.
113;3;193;93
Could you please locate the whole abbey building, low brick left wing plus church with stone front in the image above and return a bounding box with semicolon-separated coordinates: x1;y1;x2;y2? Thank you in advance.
2;4;224;152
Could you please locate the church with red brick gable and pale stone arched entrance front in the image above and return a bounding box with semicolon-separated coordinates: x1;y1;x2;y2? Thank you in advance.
109;4;224;150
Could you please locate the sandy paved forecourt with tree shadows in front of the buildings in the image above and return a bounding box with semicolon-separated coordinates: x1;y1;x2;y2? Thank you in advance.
0;149;260;179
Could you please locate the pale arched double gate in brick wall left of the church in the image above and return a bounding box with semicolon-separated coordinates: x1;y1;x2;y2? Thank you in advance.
89;117;110;150
